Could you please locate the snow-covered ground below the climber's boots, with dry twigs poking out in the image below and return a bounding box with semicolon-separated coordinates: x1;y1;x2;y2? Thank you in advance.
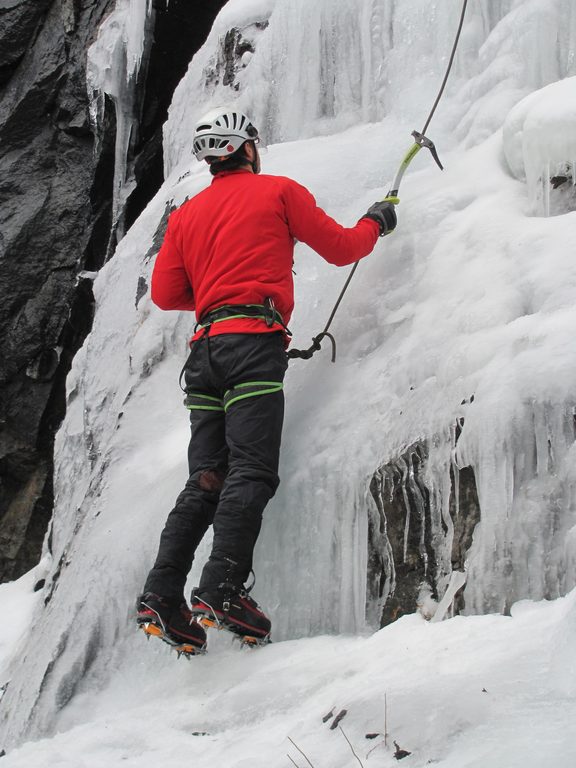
0;583;576;768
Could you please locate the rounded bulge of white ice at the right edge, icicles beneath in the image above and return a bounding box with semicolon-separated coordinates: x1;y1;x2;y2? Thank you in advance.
504;77;576;216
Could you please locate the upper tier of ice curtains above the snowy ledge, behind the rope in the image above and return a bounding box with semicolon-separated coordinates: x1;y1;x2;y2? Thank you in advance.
165;0;576;172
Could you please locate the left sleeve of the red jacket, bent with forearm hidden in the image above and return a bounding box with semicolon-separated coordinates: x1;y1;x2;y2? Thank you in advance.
151;211;194;310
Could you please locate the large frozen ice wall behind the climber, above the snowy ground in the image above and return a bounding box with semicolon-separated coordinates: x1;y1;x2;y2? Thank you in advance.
2;0;576;745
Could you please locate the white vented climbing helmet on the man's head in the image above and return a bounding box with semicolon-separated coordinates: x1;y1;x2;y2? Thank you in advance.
193;107;258;160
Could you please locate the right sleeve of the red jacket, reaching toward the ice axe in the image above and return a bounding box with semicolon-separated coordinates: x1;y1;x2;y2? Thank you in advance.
283;179;380;267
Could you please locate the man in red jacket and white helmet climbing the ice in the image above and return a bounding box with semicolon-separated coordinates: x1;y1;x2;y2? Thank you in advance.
137;108;396;653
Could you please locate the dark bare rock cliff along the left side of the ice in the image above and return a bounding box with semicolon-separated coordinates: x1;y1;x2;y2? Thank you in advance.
0;0;230;581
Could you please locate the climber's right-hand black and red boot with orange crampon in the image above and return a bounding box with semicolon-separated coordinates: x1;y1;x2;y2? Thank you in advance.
191;589;272;645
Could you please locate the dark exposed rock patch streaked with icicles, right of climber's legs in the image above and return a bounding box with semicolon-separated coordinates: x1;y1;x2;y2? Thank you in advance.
367;440;480;626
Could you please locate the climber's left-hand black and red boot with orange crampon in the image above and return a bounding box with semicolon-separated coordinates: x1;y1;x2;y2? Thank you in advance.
136;592;206;656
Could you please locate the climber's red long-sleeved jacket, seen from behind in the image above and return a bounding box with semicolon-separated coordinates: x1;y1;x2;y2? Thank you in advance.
152;170;379;335
